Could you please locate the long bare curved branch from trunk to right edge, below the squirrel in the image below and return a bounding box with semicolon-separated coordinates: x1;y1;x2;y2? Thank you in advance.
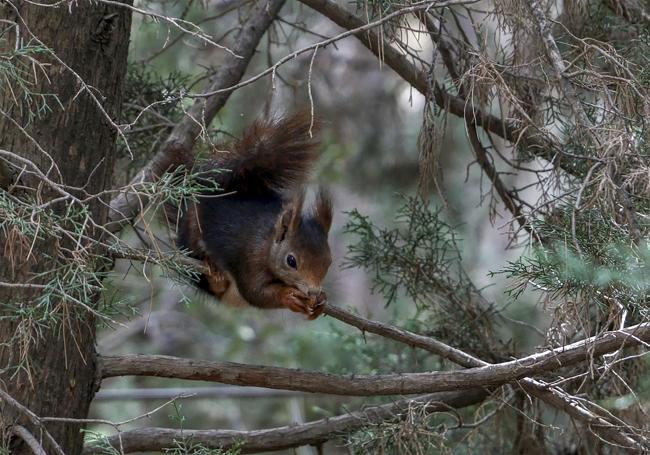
98;323;650;396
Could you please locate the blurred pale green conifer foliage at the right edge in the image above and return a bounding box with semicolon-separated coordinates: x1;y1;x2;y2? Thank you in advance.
503;208;650;319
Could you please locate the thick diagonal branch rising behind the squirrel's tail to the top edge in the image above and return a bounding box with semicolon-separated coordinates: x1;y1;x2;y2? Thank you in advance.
109;0;285;232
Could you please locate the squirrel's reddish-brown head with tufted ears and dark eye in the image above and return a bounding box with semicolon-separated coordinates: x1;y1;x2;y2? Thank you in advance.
270;190;332;296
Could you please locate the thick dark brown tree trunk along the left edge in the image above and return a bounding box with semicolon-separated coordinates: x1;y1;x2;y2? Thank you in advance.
0;4;131;455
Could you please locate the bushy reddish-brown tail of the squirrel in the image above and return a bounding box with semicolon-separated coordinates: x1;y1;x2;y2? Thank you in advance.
213;114;318;192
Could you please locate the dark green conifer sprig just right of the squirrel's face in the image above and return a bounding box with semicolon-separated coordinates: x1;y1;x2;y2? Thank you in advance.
345;197;494;356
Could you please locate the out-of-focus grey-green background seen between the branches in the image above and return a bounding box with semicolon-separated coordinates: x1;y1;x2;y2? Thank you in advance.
91;0;546;455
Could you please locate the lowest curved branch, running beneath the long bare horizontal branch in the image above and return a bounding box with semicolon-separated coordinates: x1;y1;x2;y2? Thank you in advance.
83;389;488;455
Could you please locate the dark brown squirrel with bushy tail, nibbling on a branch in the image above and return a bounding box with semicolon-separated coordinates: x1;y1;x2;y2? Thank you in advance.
168;114;332;320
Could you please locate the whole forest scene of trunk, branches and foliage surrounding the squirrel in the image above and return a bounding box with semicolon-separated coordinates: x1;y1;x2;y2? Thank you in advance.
0;0;650;455
